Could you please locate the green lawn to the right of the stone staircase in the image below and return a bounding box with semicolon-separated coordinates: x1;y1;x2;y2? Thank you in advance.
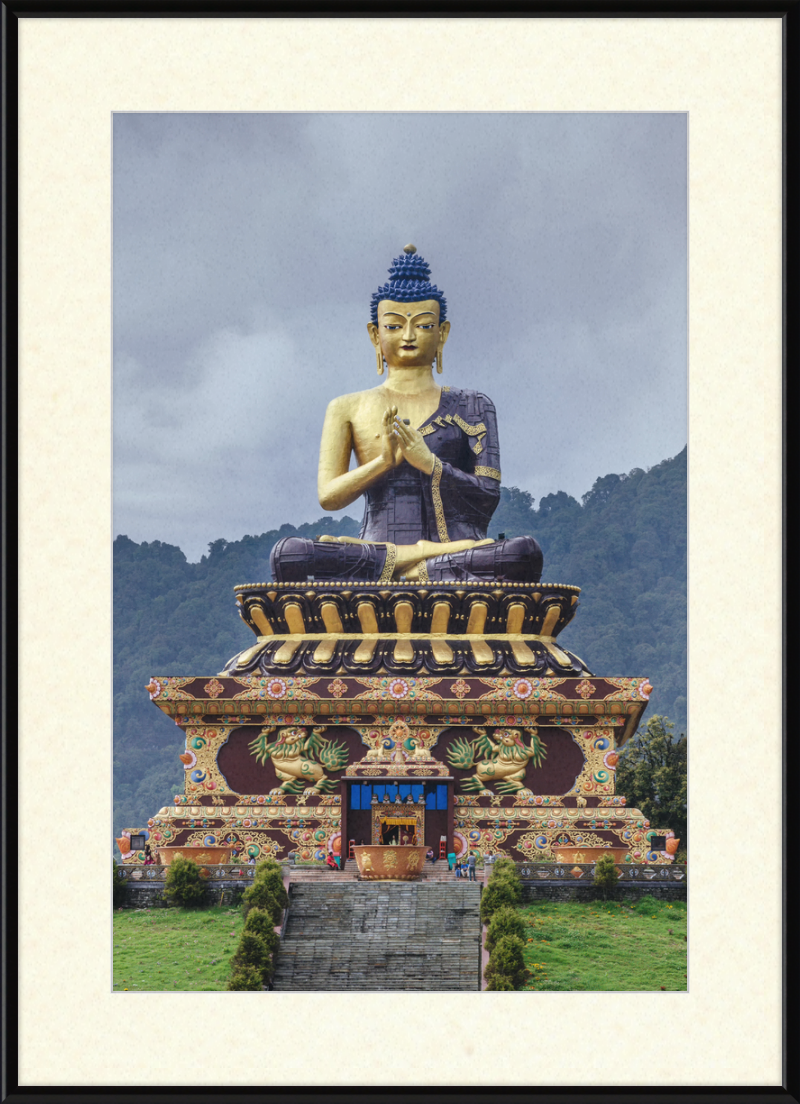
521;898;687;992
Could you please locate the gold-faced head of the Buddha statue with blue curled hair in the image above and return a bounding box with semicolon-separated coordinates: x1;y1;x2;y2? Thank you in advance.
367;245;450;369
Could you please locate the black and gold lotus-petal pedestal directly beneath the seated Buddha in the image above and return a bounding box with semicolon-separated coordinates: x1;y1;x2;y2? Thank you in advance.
223;580;589;677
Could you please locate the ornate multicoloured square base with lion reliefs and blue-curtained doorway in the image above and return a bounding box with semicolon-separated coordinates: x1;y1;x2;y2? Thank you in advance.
122;653;679;866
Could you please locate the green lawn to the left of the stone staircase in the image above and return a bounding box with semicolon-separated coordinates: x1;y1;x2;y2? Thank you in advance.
114;905;244;992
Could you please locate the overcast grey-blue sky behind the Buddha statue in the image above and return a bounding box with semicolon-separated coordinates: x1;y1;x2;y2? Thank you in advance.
114;114;686;561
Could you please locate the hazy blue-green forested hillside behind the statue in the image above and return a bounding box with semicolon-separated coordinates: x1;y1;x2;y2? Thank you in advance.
114;449;686;835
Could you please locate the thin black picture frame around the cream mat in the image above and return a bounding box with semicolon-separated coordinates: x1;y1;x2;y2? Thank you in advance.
0;0;800;1104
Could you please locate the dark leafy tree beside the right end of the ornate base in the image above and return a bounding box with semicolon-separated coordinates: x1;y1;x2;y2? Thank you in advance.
617;714;689;848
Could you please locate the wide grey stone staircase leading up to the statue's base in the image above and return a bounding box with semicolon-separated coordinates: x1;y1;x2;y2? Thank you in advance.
273;873;481;992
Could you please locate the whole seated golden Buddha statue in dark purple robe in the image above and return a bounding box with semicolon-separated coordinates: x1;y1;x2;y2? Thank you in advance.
270;245;542;583
